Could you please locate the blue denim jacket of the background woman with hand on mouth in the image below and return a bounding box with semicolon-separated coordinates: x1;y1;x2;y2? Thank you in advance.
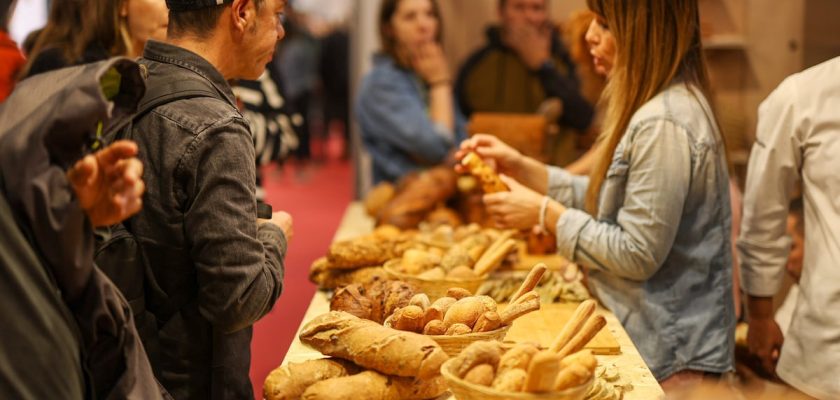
355;55;465;183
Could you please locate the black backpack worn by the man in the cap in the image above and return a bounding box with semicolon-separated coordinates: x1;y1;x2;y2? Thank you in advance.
94;73;219;371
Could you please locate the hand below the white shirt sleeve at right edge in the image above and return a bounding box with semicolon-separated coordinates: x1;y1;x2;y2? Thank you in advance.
747;296;785;377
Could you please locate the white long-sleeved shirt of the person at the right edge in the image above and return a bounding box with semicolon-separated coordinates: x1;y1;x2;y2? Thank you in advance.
738;58;840;399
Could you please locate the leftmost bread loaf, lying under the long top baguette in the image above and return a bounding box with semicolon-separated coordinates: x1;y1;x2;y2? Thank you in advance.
263;358;359;400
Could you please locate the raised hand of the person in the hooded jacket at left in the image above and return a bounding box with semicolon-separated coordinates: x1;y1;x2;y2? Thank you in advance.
67;140;146;227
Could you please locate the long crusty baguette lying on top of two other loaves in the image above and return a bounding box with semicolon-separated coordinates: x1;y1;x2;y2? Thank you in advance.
300;311;449;379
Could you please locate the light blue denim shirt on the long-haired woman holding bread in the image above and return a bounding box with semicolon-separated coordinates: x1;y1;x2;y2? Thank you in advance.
549;83;735;380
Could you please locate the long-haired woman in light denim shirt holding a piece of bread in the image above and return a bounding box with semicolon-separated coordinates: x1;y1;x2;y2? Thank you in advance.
456;0;735;391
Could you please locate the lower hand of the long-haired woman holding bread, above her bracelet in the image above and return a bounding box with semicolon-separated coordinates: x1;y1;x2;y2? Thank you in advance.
482;175;543;230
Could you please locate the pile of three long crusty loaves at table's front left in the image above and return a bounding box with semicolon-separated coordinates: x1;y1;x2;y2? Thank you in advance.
263;311;449;400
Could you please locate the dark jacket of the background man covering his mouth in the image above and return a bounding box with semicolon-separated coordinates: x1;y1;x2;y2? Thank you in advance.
455;27;594;131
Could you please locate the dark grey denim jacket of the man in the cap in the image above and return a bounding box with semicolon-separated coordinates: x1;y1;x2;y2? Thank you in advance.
121;41;286;400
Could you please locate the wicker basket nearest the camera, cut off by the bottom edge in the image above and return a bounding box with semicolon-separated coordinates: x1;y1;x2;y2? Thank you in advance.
440;358;595;400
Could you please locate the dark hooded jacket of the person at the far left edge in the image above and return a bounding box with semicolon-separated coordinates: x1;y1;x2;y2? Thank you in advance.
0;59;167;399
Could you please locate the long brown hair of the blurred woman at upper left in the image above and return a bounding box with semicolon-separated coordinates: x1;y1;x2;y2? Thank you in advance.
24;0;131;74
